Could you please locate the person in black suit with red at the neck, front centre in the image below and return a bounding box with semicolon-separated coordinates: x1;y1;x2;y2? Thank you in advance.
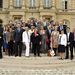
31;28;41;56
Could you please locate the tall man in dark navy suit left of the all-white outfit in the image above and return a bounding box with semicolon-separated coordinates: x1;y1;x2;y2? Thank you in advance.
14;23;23;57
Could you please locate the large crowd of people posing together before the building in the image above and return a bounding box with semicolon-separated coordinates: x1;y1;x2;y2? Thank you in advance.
0;19;75;60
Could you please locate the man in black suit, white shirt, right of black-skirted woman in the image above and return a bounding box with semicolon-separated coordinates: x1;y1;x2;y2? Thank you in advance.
66;27;74;60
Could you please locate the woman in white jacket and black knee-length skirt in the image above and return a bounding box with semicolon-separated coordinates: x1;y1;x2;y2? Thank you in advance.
58;30;67;59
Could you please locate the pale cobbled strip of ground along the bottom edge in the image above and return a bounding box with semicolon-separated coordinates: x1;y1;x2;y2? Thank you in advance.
0;68;75;75
